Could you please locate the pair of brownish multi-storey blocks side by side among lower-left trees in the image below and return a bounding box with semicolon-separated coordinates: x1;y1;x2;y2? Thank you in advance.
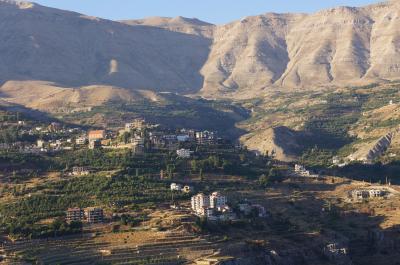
66;207;104;224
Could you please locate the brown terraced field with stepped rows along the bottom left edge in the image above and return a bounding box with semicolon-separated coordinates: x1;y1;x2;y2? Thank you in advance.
1;232;218;265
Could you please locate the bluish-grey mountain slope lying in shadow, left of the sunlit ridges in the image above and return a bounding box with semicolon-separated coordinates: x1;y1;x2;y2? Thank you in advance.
0;1;210;92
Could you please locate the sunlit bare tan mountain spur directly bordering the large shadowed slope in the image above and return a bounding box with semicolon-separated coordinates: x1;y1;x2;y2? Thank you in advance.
201;14;302;96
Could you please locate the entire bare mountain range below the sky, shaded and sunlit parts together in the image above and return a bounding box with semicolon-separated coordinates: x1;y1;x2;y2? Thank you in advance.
0;0;400;98
